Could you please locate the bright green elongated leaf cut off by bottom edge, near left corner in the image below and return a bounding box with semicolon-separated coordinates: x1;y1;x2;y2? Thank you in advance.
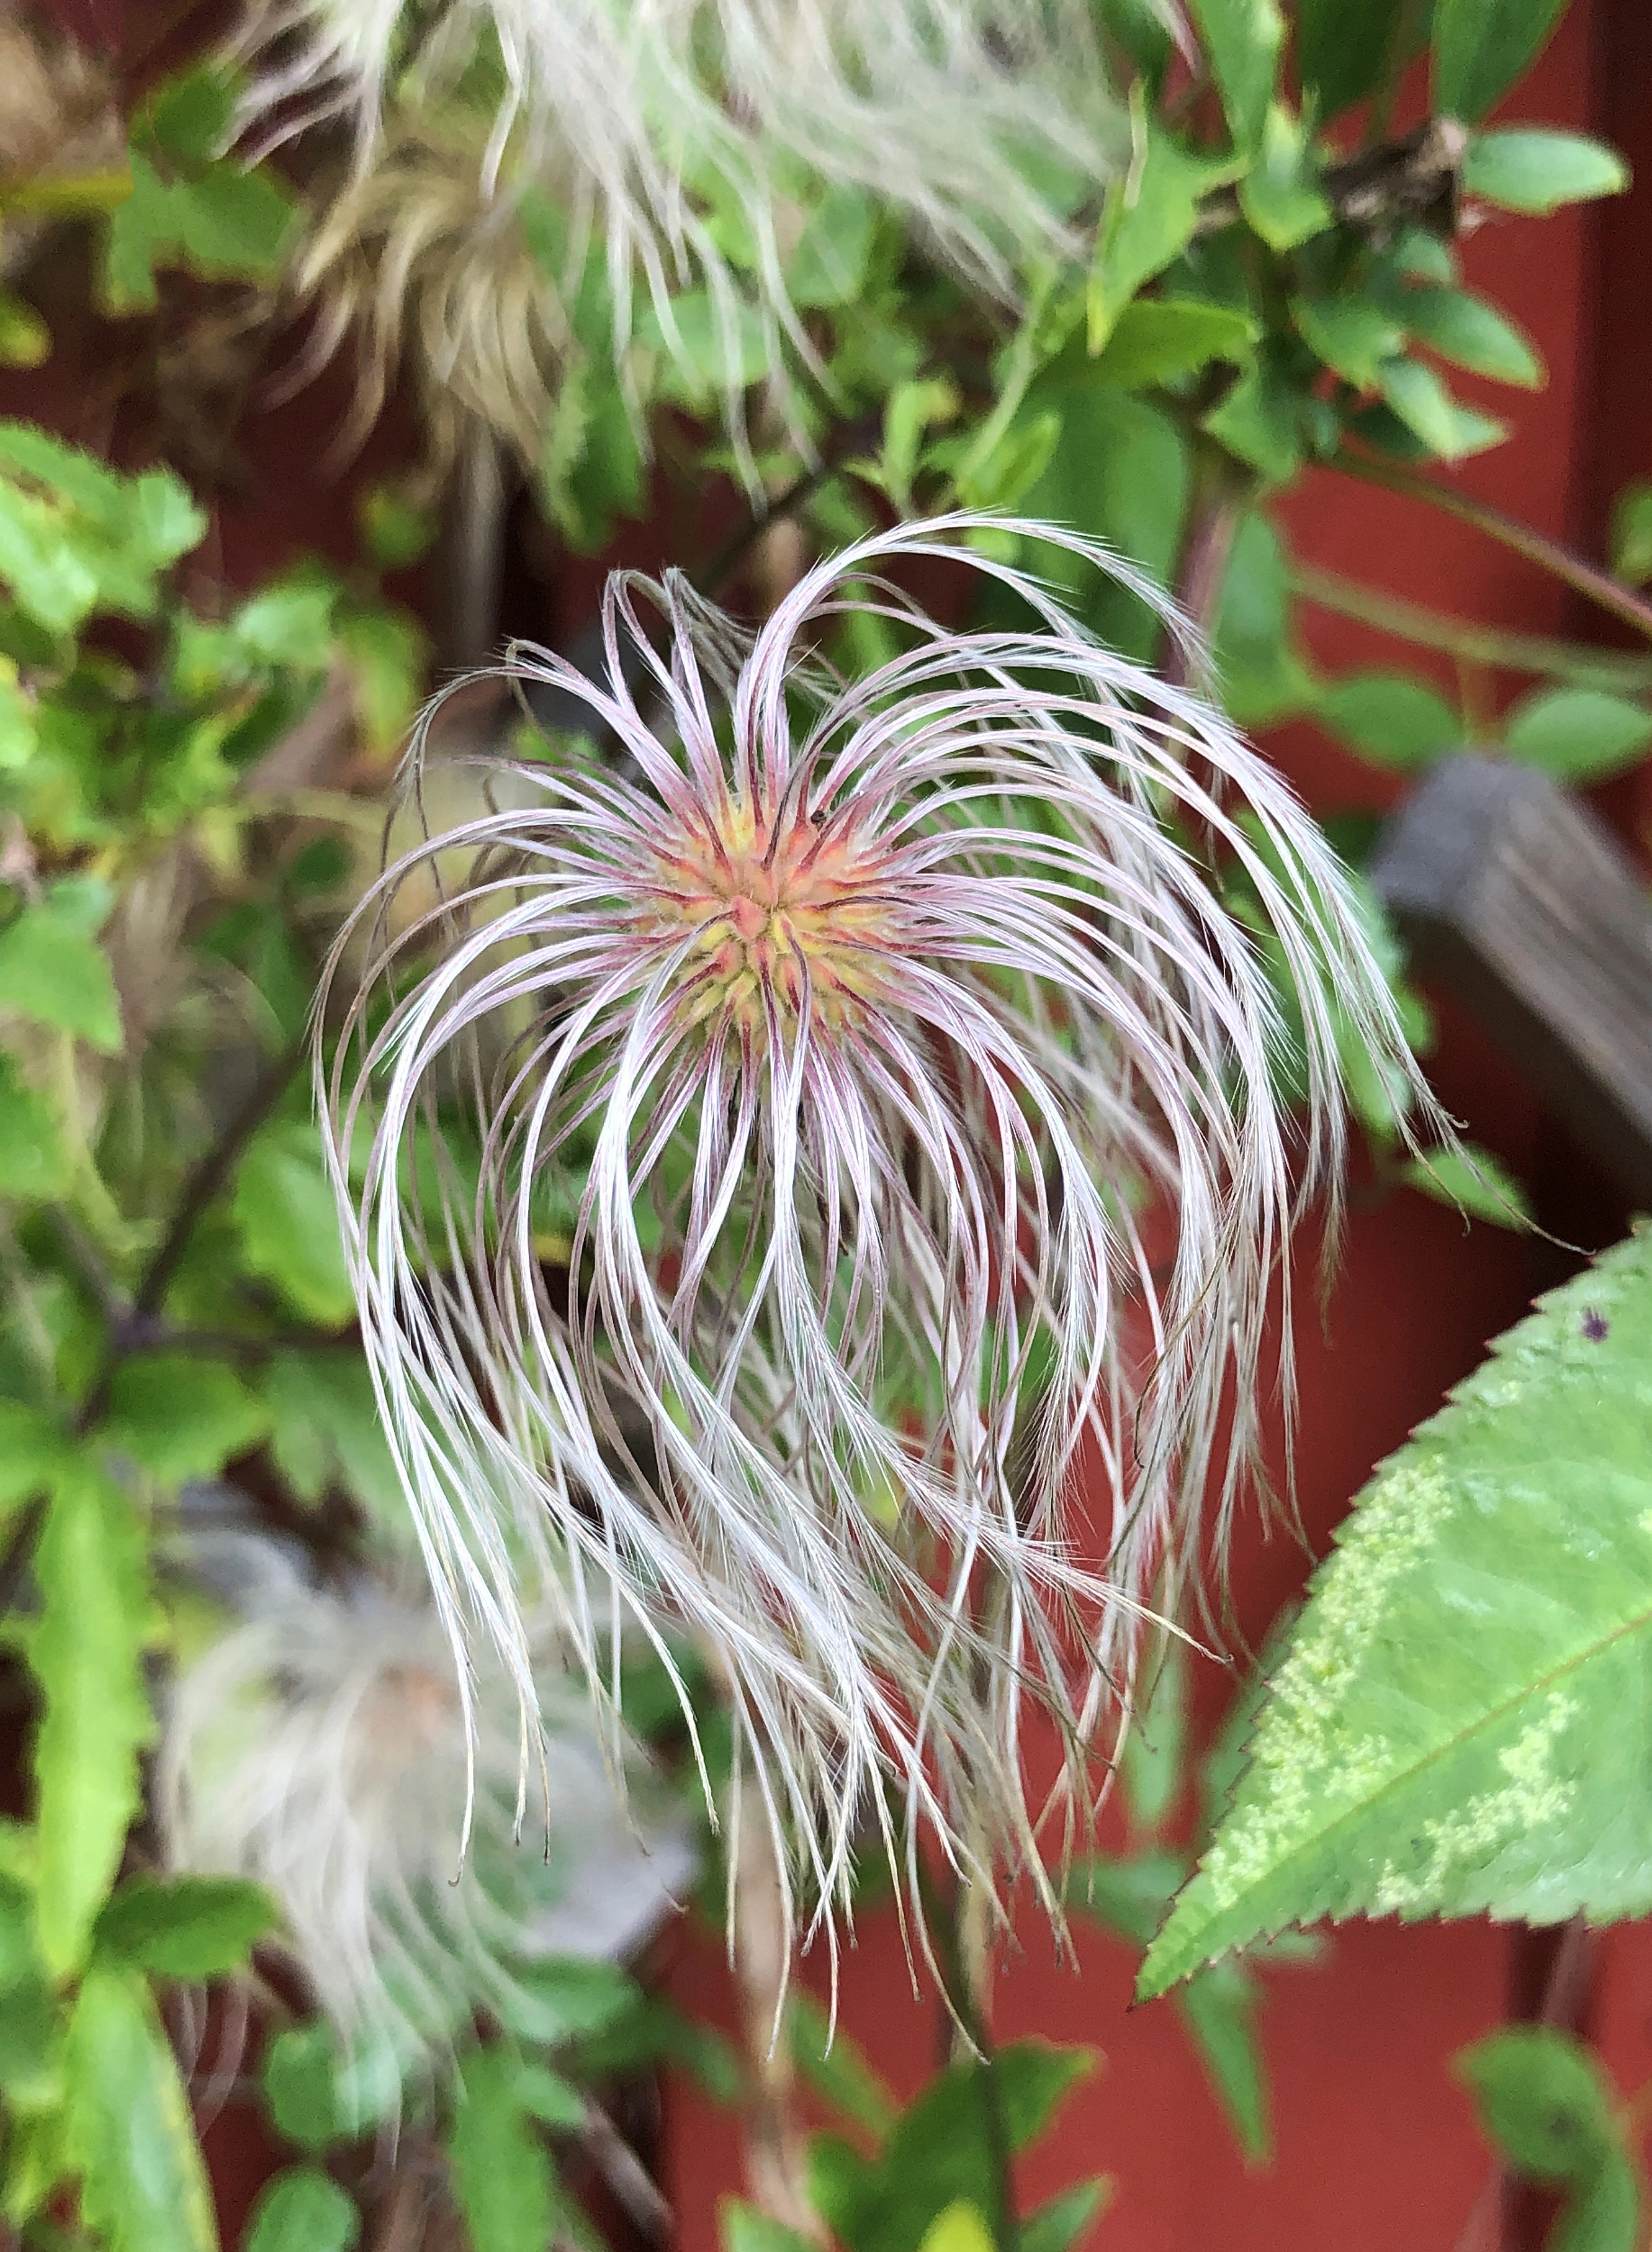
63;1968;218;2252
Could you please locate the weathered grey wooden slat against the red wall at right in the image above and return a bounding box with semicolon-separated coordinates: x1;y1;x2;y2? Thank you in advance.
1371;756;1652;1207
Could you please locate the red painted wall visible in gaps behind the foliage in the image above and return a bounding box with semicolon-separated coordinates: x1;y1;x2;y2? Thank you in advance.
19;0;1652;2252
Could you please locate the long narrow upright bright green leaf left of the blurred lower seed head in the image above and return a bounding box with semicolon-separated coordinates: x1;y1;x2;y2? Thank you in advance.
29;1461;153;1975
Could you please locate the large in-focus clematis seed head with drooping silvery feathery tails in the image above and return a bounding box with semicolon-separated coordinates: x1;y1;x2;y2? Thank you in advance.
317;516;1438;1921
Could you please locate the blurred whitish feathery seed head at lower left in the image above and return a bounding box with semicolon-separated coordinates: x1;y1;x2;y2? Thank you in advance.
158;1536;693;2079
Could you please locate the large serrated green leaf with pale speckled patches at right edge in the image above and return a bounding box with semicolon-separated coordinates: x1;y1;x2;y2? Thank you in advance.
1141;1234;1652;1995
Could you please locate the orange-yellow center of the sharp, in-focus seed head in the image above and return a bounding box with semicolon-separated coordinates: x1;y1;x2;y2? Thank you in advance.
657;806;894;1020
